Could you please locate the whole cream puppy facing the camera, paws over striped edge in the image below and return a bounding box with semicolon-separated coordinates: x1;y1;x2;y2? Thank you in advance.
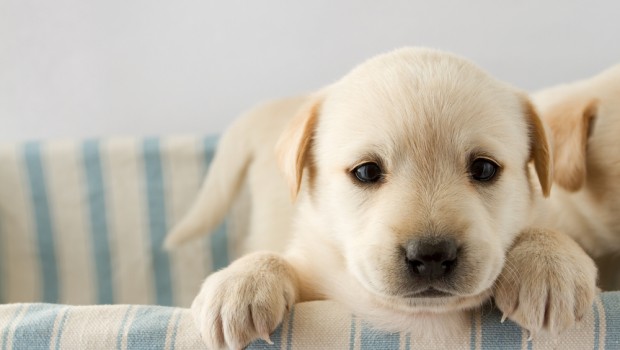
167;49;596;348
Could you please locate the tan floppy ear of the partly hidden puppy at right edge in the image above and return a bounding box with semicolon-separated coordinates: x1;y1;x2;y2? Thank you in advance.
545;99;598;192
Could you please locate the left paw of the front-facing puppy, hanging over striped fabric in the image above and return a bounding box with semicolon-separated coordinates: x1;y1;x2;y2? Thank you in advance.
191;253;297;349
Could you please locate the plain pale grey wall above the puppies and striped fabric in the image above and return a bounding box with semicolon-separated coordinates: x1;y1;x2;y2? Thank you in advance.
0;0;620;141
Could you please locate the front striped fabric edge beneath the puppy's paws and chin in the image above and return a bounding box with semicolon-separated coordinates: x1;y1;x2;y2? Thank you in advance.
0;292;620;350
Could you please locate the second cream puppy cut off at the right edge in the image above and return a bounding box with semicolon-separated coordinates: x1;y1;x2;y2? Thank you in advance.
533;65;620;288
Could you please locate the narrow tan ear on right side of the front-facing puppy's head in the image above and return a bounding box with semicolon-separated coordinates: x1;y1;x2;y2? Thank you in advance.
525;100;553;197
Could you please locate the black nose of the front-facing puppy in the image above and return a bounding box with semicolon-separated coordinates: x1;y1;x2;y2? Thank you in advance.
405;239;458;280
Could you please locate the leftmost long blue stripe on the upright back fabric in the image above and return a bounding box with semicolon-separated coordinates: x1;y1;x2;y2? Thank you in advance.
24;142;58;303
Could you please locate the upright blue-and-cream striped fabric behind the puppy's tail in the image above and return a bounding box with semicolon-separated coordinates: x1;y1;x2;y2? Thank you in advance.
0;137;233;306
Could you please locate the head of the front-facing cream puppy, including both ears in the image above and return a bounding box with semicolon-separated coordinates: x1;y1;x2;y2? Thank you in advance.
279;49;550;311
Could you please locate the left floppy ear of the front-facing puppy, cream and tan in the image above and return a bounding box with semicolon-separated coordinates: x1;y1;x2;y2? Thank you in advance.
276;97;321;200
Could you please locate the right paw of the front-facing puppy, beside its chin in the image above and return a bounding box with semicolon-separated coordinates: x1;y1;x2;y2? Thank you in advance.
494;229;597;338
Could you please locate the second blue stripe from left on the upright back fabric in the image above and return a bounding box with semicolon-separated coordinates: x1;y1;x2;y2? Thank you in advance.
82;140;114;304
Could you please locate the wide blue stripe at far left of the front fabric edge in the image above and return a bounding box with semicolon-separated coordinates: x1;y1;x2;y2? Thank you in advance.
12;304;62;350
